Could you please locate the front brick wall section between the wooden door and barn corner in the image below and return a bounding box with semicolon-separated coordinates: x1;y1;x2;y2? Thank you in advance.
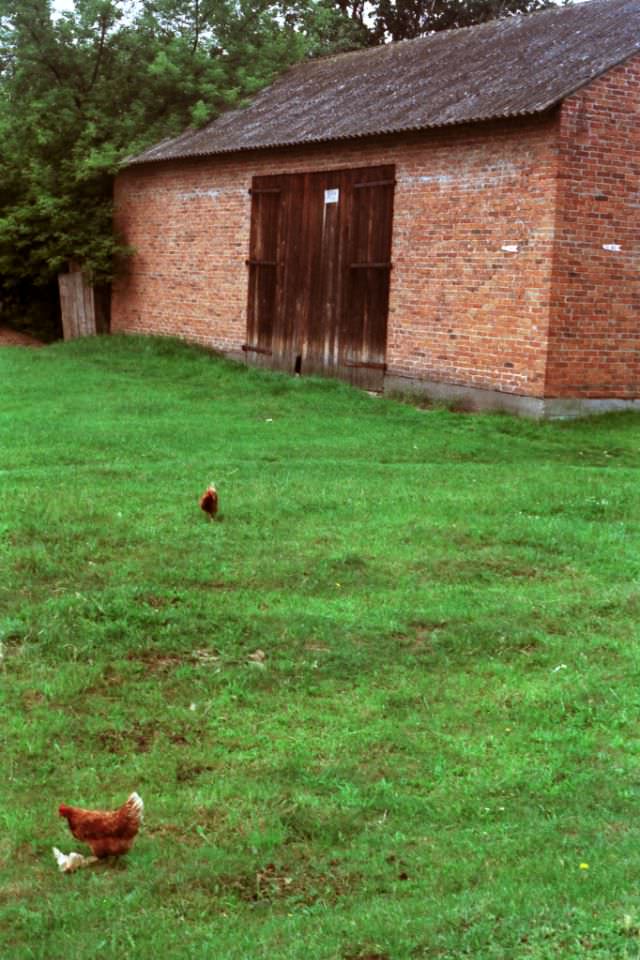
387;117;556;396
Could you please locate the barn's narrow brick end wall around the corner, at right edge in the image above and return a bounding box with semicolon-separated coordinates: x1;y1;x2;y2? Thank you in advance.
546;57;640;399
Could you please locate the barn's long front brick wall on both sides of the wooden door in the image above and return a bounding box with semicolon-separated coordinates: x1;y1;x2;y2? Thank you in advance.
112;115;557;396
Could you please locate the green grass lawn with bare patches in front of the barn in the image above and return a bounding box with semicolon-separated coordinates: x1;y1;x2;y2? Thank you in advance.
0;337;640;960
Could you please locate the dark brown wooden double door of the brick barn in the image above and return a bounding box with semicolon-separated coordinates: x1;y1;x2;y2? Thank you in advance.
244;165;395;390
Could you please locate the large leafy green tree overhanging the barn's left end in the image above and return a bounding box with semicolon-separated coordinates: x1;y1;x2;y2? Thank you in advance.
0;0;320;334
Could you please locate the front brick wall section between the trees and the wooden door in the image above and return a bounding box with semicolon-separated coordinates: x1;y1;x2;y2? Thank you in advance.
111;163;249;350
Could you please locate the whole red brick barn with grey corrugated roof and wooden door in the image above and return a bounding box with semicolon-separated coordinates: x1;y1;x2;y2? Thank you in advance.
112;0;640;416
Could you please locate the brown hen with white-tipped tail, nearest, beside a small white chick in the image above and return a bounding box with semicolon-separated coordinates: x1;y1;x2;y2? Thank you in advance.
58;793;144;859
